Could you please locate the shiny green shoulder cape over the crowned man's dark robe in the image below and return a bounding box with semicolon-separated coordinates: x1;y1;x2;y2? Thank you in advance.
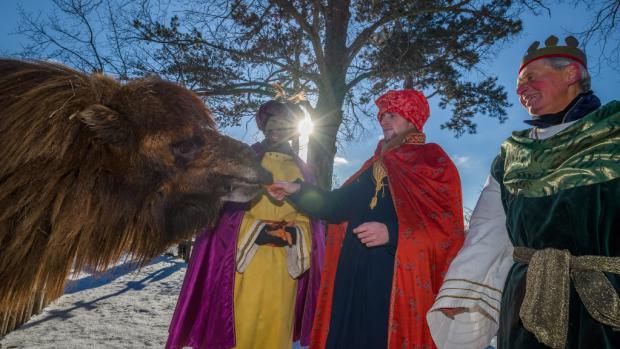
491;101;620;197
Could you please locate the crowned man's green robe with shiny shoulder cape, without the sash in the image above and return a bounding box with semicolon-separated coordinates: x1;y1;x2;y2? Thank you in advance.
492;102;620;349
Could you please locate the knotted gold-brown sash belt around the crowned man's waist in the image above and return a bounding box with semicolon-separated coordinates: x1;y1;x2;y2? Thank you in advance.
514;247;620;348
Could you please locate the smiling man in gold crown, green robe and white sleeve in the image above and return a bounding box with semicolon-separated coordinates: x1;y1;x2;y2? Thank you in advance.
428;36;620;349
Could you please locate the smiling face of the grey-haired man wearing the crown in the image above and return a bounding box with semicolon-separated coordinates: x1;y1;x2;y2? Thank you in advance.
517;59;579;116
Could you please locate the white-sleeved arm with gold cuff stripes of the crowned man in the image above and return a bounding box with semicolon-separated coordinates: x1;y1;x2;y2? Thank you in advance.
427;177;513;349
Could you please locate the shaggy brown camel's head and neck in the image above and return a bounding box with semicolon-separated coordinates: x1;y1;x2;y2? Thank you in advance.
0;59;271;336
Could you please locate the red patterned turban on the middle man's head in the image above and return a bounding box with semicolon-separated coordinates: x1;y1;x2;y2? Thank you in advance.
375;90;430;132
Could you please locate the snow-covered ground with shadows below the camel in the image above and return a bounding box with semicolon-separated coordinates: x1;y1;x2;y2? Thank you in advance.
0;256;308;349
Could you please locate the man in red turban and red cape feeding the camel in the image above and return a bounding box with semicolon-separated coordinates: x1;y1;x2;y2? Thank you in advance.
269;90;463;349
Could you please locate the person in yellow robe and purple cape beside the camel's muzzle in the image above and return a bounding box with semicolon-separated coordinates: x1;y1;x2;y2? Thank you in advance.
166;100;325;349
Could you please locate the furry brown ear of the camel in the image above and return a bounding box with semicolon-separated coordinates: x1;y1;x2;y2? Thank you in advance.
76;104;131;145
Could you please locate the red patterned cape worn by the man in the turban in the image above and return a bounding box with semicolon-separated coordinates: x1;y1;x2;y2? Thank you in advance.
310;134;464;349
